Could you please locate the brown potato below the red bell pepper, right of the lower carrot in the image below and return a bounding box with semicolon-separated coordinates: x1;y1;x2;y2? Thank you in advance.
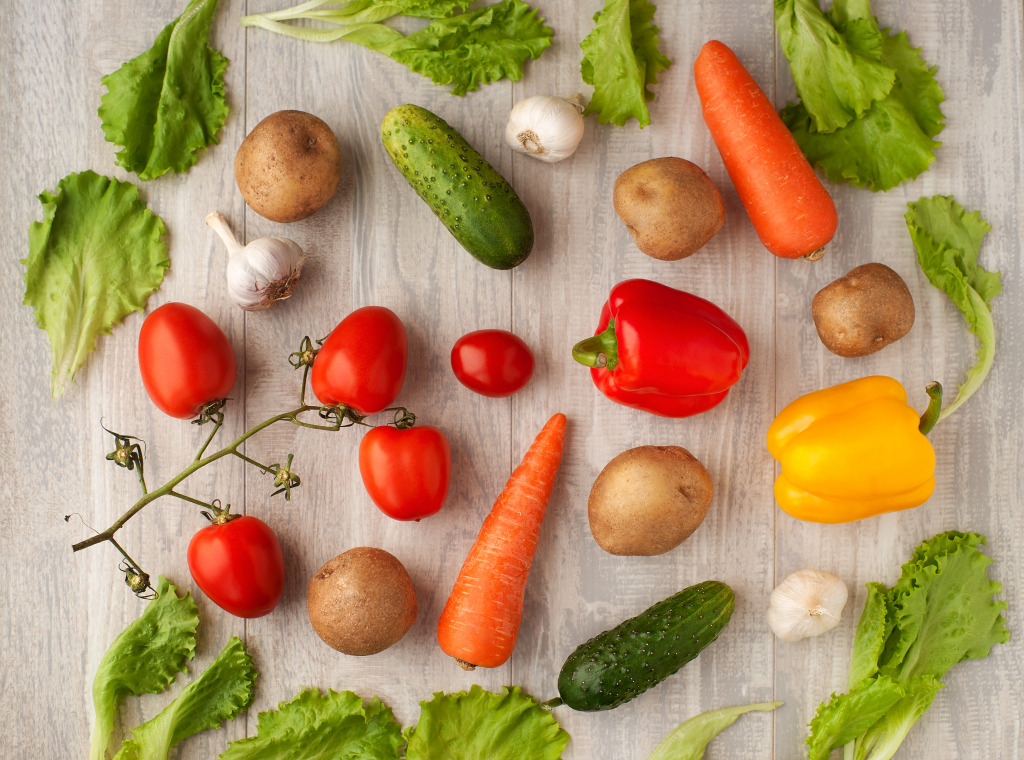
587;446;714;556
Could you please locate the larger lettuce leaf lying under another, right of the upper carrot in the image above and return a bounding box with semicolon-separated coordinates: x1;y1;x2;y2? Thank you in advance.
776;0;944;192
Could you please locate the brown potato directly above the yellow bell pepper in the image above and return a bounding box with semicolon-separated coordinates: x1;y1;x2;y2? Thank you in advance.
811;262;913;356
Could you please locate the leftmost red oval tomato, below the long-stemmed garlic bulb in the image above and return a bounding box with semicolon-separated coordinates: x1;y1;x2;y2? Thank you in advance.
138;303;236;420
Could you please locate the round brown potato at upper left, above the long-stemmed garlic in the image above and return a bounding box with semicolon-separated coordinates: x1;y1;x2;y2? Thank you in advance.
234;111;341;222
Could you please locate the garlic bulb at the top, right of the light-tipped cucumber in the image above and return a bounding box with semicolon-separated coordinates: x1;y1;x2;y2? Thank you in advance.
505;95;583;163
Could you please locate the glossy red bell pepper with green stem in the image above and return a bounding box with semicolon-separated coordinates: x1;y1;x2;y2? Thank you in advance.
572;280;751;417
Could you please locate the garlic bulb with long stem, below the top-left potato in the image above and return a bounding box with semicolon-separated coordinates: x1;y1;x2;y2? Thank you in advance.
206;211;305;311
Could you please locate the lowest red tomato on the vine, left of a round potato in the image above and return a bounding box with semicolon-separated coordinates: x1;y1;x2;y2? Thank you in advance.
188;516;285;618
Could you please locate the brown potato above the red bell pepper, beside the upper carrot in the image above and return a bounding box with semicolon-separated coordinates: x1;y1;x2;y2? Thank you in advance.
611;157;725;261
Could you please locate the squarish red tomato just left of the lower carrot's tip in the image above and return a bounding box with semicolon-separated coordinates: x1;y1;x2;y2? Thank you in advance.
359;425;452;520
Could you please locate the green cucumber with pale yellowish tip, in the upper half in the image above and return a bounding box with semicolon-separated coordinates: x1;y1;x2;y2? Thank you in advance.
381;105;534;269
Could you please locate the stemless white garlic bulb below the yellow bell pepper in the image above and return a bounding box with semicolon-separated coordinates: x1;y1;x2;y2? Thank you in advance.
768;569;848;641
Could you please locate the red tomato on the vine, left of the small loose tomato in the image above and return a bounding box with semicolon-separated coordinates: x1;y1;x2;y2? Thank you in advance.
309;306;409;414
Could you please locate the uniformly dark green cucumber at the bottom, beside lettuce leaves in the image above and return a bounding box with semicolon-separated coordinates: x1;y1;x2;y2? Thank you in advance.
558;581;735;711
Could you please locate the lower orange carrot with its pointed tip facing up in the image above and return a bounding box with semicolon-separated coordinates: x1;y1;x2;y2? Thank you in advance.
437;414;565;670
